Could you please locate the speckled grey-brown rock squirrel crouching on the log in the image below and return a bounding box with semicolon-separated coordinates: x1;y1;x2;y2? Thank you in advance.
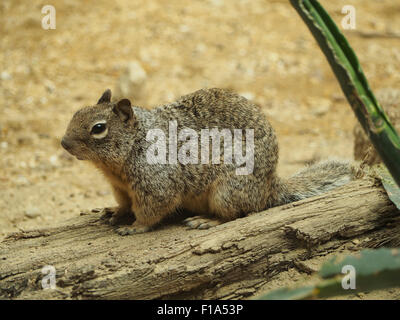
61;88;355;235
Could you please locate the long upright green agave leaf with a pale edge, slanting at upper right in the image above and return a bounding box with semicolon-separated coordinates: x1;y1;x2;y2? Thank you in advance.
290;0;400;186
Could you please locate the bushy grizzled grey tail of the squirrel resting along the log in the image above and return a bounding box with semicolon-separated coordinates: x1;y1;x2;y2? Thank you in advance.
281;160;357;203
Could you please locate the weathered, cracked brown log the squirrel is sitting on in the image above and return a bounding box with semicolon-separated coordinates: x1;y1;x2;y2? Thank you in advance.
0;179;400;299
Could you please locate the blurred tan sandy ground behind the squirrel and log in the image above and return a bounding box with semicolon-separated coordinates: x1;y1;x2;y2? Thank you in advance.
0;0;400;298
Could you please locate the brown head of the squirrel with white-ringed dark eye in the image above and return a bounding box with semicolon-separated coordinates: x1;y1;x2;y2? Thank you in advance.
61;89;136;163
